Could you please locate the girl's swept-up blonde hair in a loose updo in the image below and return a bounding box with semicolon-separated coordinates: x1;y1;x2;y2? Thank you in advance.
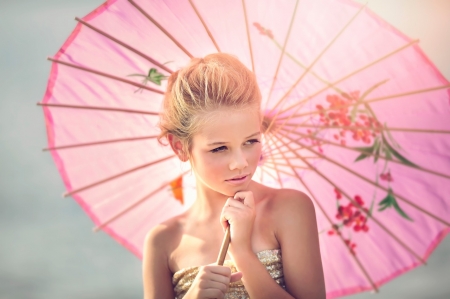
158;53;261;155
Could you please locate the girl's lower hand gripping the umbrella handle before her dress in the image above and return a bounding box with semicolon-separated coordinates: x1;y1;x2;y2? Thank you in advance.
183;265;242;299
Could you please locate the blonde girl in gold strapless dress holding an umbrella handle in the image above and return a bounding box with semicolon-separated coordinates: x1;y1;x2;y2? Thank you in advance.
143;54;325;299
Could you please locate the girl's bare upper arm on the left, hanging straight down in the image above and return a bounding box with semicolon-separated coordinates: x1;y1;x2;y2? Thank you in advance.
142;225;175;299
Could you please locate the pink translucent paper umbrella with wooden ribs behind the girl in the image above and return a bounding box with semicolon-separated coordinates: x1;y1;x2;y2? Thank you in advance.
39;0;450;298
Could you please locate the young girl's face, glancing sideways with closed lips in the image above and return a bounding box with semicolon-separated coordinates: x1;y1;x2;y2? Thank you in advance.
191;108;261;196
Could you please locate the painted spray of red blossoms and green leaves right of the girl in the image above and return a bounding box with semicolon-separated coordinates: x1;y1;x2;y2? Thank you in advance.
253;23;419;254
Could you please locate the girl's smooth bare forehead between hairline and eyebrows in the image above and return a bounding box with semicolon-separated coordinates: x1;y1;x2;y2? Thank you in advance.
193;108;261;142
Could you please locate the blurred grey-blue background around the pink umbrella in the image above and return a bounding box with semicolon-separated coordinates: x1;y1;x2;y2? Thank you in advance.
0;0;450;299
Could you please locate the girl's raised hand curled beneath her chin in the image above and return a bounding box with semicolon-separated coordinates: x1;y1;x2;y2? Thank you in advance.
220;191;255;255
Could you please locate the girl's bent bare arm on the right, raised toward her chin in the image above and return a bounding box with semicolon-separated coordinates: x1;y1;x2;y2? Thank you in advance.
222;190;325;299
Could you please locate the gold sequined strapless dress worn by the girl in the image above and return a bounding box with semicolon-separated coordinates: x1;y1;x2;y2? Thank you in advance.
172;249;285;299
